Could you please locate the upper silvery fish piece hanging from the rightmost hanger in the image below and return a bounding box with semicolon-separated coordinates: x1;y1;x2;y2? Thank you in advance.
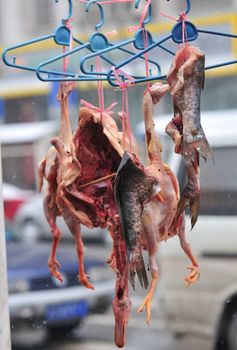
167;45;214;164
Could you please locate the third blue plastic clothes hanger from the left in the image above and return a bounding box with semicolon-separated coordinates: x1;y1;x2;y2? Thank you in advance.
80;0;161;78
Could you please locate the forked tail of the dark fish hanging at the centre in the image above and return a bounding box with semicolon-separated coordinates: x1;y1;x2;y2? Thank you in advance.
129;250;148;289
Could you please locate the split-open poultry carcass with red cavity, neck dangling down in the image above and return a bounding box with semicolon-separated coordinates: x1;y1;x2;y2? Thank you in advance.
48;101;136;347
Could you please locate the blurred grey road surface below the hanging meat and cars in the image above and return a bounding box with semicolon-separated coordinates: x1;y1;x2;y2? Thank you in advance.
13;297;211;350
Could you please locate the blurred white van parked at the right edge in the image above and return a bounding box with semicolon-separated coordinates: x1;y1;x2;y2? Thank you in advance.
137;110;237;350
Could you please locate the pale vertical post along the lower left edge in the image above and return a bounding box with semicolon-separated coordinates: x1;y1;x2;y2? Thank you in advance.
0;144;11;350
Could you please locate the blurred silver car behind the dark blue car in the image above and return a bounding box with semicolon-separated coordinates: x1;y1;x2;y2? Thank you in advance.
15;194;110;244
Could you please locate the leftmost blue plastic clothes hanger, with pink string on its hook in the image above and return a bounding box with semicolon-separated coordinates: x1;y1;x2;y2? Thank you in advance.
2;0;82;76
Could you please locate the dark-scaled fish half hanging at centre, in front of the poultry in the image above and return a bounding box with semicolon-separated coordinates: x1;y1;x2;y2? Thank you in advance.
114;151;160;289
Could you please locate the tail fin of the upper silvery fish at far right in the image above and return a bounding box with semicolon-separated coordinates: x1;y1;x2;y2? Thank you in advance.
182;126;215;164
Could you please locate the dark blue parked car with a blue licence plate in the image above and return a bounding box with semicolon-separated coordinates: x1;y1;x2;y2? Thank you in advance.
6;222;114;344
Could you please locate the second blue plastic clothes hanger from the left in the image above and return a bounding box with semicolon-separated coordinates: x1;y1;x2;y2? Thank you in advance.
36;0;160;81
